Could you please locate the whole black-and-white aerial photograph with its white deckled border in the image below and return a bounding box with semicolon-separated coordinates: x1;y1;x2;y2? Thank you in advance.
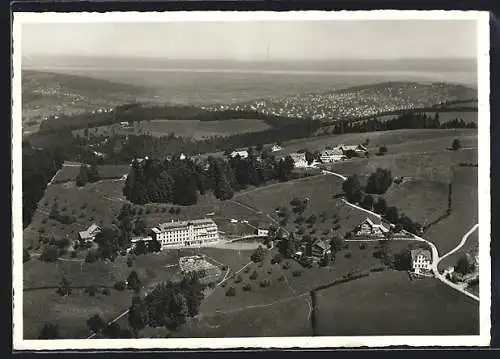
12;11;491;350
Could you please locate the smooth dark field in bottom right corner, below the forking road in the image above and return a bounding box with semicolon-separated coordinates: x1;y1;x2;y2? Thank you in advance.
315;271;479;336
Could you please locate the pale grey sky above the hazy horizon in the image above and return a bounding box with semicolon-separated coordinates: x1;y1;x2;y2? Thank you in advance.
22;20;477;61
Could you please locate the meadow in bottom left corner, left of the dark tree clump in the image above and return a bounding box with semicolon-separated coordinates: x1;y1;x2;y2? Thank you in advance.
23;252;184;339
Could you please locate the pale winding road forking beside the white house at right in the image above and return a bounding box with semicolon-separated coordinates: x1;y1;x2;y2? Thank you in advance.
323;170;479;301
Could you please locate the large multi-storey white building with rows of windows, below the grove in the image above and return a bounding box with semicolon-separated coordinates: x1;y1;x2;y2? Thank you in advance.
151;219;219;249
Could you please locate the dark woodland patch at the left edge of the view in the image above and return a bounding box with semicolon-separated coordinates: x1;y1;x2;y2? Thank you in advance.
22;142;64;228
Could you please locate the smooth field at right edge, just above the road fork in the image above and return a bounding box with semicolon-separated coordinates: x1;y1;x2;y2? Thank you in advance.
424;167;478;255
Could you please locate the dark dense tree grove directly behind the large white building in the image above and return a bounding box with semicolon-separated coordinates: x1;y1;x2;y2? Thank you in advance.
123;152;293;205
